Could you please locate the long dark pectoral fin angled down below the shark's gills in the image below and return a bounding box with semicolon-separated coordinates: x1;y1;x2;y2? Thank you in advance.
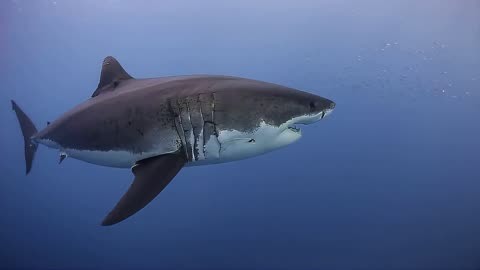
102;154;186;226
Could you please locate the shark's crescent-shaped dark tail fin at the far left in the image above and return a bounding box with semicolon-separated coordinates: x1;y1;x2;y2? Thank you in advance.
12;100;37;174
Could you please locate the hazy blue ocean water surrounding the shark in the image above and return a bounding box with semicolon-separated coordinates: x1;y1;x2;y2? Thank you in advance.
0;0;480;269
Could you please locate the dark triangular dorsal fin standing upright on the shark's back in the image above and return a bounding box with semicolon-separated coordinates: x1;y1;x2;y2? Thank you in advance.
92;56;133;97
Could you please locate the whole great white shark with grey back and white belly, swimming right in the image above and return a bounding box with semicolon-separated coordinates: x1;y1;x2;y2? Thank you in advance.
12;56;335;225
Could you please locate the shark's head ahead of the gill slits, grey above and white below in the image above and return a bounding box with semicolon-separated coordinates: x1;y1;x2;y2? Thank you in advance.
208;78;335;162
